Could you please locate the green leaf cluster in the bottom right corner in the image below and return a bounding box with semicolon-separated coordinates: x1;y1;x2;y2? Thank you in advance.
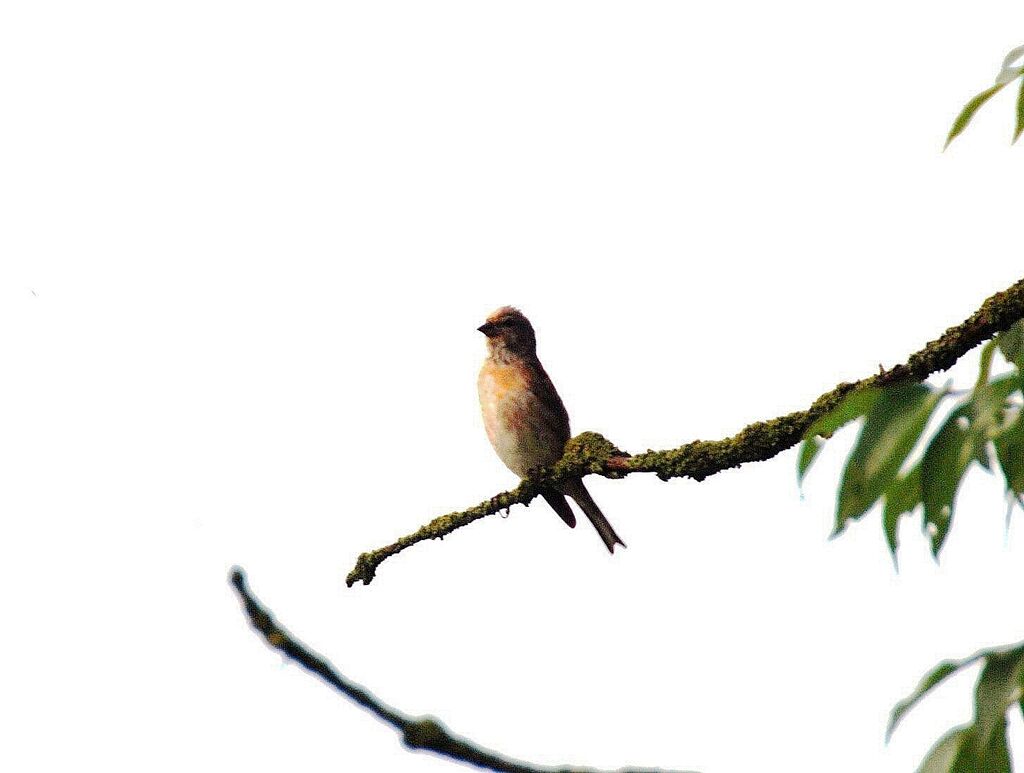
886;643;1024;773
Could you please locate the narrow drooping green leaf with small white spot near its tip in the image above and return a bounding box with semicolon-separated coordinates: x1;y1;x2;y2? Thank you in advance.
921;400;974;556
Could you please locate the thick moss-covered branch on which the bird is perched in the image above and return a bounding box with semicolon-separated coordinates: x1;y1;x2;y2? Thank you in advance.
345;280;1024;587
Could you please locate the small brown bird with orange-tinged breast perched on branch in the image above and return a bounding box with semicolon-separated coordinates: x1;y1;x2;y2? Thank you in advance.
477;306;626;553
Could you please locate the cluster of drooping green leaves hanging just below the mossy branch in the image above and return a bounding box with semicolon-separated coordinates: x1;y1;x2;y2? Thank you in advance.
797;321;1024;561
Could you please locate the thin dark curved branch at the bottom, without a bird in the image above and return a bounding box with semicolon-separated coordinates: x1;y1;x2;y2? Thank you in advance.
230;567;692;773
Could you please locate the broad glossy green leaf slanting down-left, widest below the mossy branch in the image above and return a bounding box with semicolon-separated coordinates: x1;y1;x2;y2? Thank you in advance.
833;384;945;535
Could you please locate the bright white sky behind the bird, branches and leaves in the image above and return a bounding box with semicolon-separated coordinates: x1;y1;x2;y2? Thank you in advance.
0;0;1024;773
